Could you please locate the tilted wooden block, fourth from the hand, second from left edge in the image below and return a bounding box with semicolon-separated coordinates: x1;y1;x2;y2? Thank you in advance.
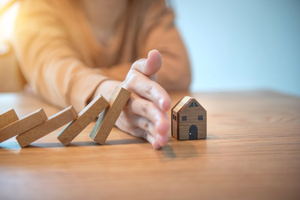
0;108;47;143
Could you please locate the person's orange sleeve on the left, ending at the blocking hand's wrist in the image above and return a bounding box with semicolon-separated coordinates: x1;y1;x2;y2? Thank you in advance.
14;1;108;112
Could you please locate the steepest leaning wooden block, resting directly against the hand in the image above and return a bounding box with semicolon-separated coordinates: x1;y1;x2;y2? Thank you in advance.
90;86;131;144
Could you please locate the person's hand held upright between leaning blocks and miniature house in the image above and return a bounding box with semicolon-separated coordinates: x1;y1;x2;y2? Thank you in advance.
95;50;171;149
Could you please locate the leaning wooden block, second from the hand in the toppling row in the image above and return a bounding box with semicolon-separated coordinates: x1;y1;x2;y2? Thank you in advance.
57;94;109;146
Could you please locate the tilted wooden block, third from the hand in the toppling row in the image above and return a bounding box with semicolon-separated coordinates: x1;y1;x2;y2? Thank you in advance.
16;106;77;147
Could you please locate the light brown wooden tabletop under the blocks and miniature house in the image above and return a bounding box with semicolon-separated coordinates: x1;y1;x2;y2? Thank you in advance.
0;91;300;199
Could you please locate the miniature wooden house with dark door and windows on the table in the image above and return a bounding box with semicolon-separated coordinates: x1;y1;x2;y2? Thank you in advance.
171;96;207;140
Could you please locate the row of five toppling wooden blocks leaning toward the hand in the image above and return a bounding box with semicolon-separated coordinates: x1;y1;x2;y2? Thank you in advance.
0;86;131;147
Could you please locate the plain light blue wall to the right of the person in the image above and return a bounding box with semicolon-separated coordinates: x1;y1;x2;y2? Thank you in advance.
171;0;300;96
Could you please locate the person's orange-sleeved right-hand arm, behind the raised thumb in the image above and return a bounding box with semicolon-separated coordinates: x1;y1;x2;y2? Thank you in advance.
138;0;191;90
